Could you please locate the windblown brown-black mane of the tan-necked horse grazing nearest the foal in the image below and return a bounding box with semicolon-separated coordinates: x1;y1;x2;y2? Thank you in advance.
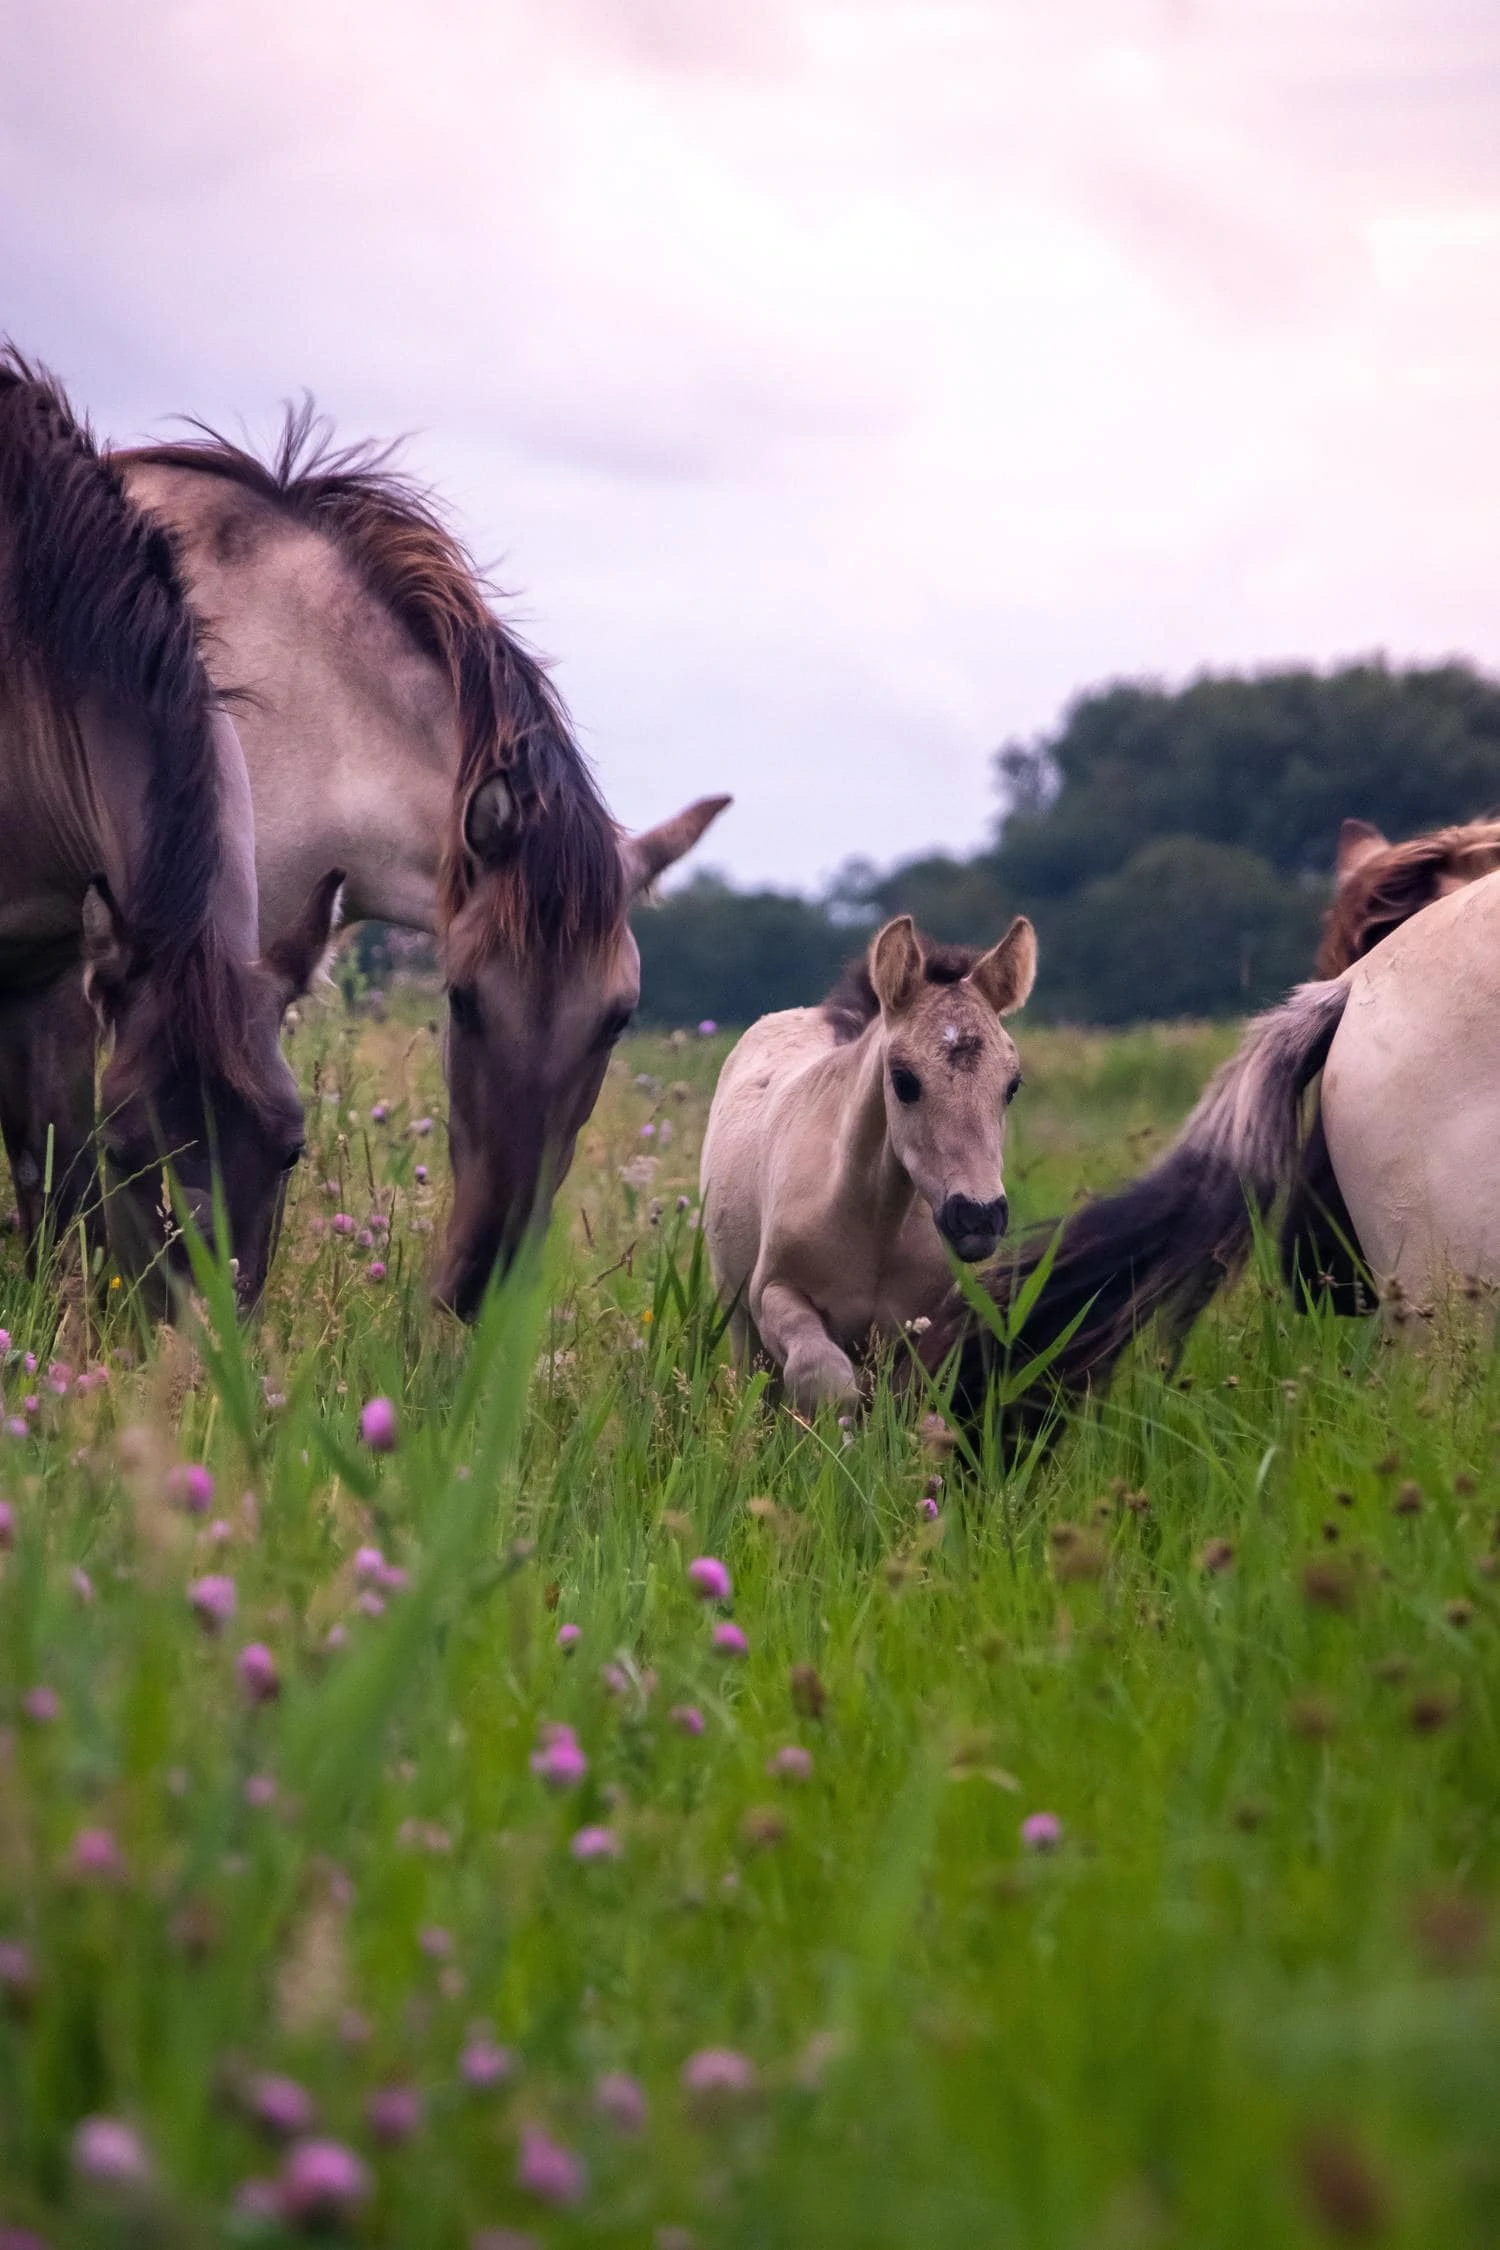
119;398;625;963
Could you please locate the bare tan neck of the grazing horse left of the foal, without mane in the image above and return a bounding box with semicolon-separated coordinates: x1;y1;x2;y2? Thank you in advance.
116;464;459;945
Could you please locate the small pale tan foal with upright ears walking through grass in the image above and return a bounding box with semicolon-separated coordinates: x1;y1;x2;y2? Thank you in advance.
702;914;1037;1413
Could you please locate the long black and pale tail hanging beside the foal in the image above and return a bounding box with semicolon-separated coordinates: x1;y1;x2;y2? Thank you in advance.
922;977;1349;1427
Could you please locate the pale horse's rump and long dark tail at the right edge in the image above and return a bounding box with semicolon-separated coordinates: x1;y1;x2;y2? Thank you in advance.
922;873;1500;1422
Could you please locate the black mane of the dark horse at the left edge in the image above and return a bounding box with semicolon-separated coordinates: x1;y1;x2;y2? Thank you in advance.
0;344;254;1098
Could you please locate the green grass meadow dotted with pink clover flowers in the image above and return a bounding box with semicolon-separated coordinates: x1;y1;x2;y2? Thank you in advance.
0;1010;1500;2250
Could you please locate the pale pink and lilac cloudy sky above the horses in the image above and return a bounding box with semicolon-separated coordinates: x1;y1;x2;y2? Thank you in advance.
0;0;1500;889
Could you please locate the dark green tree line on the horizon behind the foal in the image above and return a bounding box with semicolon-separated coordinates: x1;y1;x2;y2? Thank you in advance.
634;659;1500;1024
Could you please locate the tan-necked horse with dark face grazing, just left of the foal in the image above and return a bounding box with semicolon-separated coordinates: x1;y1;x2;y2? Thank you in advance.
0;407;729;1316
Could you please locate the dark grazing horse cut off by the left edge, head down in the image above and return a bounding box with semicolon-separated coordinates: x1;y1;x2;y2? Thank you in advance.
0;351;337;1298
